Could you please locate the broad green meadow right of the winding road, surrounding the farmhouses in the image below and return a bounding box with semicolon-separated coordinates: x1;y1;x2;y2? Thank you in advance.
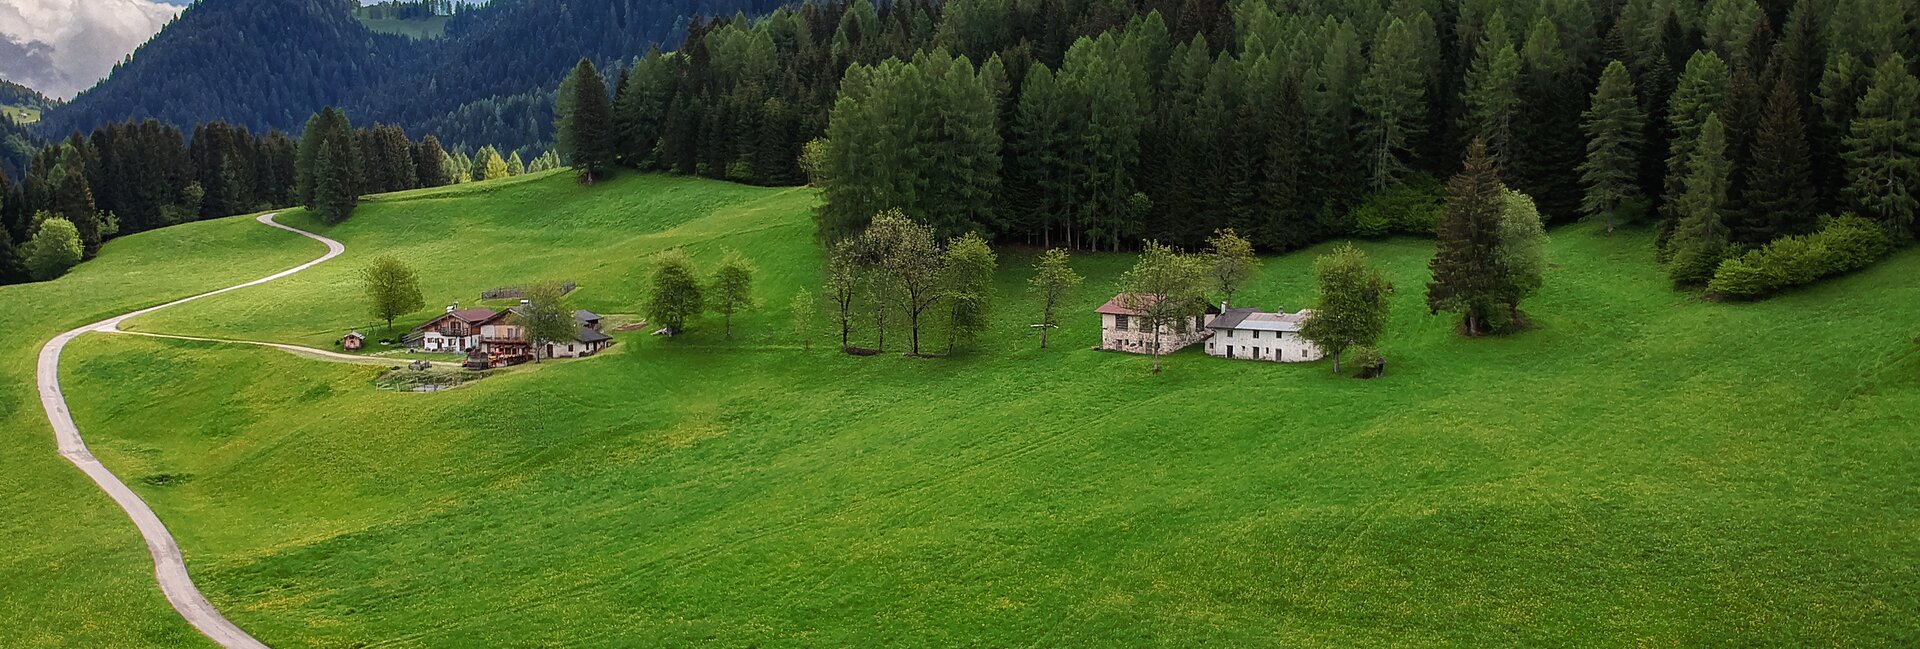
26;169;1920;647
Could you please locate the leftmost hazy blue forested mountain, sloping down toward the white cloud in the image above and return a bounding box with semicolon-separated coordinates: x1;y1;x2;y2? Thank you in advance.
42;0;419;134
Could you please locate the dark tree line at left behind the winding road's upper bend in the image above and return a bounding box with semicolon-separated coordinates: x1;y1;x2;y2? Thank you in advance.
0;108;561;284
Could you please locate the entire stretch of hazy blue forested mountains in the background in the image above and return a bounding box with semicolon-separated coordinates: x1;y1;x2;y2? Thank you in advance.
40;0;787;150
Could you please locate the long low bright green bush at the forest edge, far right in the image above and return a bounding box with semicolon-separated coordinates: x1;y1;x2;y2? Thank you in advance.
1707;215;1895;298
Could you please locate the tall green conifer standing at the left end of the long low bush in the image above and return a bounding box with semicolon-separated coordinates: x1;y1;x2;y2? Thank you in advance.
1667;113;1732;286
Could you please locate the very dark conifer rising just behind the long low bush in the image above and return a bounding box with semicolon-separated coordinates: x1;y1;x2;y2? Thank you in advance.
1736;79;1818;246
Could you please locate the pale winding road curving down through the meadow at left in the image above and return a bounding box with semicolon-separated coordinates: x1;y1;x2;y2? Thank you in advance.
36;213;348;649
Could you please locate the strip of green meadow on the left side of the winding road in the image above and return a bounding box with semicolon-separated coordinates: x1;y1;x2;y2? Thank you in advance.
0;217;324;647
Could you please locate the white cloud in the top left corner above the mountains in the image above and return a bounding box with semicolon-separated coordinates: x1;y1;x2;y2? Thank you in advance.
0;0;180;98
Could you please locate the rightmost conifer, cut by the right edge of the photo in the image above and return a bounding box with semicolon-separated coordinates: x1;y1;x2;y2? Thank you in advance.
1845;54;1920;236
